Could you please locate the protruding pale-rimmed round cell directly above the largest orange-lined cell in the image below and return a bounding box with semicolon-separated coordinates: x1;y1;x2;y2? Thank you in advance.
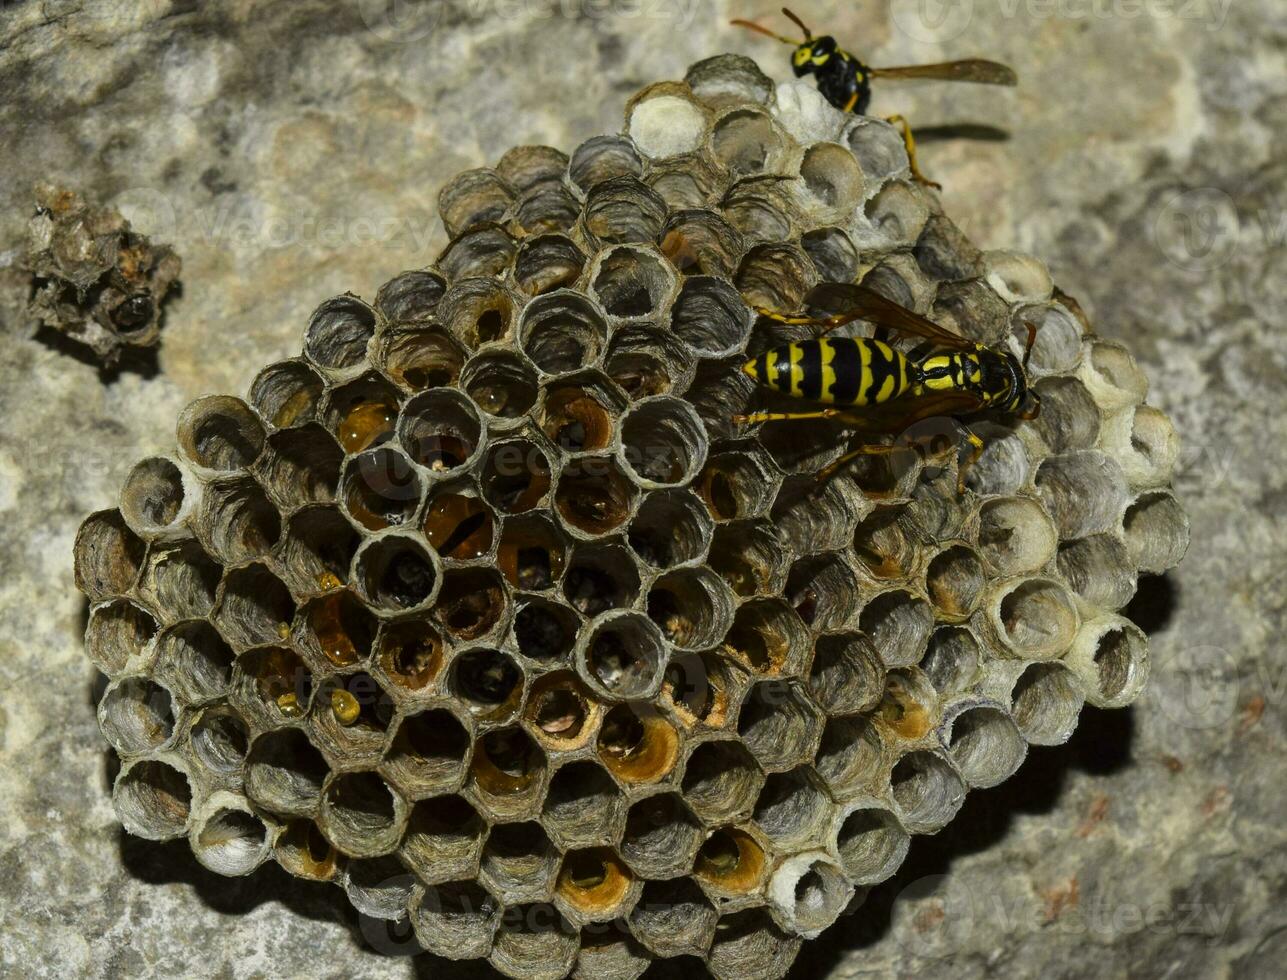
577;610;667;701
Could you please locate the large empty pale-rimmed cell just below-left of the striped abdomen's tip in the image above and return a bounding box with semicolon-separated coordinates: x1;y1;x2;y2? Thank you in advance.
622;395;707;488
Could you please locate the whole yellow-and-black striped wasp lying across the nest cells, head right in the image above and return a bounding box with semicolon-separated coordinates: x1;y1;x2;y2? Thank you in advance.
734;283;1041;493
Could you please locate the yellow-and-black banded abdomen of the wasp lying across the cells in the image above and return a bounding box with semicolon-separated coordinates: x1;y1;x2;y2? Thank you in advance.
743;337;919;406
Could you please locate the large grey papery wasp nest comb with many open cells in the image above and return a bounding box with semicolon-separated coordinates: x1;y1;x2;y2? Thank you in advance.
76;57;1187;977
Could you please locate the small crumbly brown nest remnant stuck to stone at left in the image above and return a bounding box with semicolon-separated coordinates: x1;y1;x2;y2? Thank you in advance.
27;184;181;363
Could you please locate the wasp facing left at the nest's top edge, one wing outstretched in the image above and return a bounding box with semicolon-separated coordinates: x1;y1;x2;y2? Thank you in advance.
730;6;1018;187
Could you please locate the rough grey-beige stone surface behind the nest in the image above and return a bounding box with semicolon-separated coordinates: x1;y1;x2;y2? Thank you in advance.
0;0;1287;979
